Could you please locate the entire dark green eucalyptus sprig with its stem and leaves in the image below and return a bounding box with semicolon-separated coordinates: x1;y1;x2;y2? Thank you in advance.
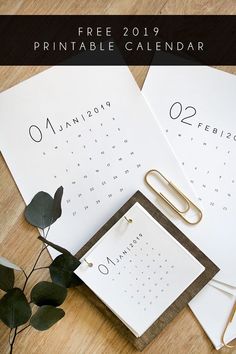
0;187;82;353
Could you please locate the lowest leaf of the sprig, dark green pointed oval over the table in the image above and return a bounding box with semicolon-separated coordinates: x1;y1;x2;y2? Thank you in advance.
30;305;65;331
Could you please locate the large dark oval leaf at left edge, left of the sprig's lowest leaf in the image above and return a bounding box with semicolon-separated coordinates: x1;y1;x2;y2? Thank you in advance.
0;288;31;328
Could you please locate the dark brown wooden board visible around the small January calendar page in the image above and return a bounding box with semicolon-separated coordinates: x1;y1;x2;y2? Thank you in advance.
75;191;219;351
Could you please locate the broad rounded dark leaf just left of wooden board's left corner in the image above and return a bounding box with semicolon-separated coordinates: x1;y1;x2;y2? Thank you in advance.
49;254;80;288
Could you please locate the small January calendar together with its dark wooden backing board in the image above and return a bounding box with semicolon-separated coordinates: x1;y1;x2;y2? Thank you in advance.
75;191;219;349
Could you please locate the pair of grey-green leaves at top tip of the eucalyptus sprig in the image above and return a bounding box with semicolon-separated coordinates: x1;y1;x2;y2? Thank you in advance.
25;187;63;229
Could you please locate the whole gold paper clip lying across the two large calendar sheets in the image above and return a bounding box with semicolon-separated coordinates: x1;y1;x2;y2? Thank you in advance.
144;170;202;225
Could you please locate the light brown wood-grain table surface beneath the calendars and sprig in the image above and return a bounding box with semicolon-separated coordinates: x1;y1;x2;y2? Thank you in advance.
0;0;236;354
